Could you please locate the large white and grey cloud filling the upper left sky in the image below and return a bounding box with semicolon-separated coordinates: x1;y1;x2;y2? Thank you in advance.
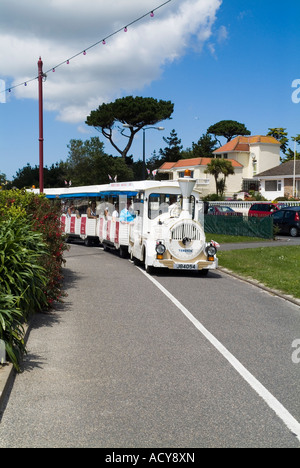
0;0;221;123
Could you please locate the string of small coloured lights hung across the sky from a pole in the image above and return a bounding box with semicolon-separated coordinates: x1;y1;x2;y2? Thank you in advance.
1;0;172;93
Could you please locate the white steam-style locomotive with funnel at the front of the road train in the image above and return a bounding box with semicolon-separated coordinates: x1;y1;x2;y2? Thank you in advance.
124;173;218;274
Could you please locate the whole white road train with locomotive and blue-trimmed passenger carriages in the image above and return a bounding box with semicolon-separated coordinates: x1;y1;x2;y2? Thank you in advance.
40;173;218;275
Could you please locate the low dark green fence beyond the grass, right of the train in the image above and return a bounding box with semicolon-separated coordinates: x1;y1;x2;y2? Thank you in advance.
204;215;273;239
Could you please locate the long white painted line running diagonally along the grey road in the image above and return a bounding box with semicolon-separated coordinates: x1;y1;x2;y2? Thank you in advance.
139;268;300;442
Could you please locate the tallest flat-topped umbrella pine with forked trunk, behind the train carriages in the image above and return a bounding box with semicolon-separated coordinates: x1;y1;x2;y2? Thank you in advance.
86;96;174;159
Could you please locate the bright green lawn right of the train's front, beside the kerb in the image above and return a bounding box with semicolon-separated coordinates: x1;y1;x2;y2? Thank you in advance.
218;246;300;298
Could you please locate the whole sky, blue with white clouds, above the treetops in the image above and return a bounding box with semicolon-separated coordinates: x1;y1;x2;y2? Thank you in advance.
0;0;300;179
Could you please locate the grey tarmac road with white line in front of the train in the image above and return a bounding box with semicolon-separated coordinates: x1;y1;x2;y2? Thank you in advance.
0;245;300;448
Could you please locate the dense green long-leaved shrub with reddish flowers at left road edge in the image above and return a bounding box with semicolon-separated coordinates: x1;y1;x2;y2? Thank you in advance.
0;190;66;368
